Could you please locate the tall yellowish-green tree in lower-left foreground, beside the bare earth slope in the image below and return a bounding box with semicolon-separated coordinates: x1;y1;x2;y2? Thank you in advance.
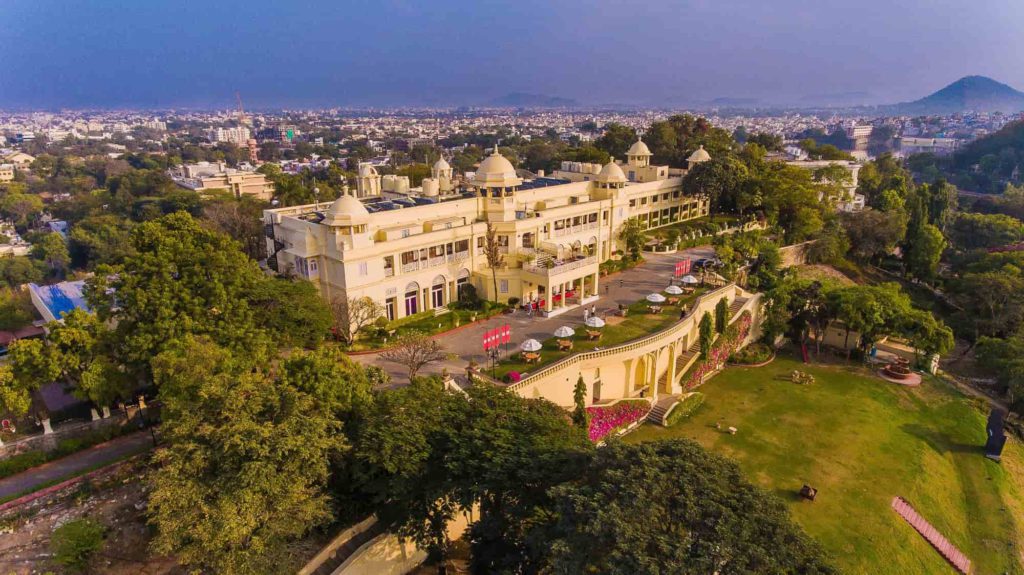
147;337;343;575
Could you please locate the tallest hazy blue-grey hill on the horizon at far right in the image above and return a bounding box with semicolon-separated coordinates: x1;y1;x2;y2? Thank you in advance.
889;76;1024;115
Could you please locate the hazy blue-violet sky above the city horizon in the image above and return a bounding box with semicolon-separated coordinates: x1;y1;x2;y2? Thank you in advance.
0;0;1024;107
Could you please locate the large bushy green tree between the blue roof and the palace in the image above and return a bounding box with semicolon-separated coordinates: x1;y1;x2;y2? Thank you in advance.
86;212;268;375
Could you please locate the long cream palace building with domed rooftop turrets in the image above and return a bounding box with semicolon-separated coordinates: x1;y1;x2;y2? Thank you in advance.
264;140;710;320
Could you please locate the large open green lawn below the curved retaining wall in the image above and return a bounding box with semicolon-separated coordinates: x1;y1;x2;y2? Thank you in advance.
625;356;1024;575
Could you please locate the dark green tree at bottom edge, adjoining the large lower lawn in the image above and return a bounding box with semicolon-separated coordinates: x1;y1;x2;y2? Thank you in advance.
538;440;836;575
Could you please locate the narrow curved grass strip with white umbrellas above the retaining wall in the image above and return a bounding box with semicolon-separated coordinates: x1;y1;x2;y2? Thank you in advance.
493;288;707;379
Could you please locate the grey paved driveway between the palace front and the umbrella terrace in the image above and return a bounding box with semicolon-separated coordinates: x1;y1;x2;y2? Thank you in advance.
352;246;714;385
